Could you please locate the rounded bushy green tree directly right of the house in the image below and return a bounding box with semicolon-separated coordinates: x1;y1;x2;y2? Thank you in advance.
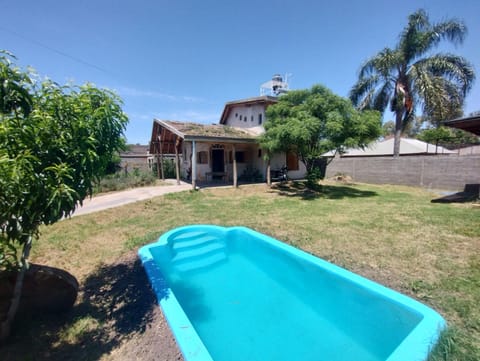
260;85;381;183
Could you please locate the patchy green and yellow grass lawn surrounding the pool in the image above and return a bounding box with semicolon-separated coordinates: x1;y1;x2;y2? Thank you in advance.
1;183;480;360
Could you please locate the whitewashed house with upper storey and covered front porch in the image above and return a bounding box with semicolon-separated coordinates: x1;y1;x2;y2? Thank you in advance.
149;95;306;187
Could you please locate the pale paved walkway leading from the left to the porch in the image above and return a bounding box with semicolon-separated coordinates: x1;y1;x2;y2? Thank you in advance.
72;179;192;217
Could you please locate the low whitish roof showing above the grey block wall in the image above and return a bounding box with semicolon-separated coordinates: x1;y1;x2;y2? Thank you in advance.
323;138;457;158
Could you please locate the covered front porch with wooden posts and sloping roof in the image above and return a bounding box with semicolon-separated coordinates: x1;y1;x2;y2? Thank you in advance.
150;119;267;188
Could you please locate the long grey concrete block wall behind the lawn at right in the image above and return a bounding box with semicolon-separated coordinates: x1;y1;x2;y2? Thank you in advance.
326;155;480;191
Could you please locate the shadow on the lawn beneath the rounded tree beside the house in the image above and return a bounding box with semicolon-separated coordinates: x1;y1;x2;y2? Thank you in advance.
272;181;378;200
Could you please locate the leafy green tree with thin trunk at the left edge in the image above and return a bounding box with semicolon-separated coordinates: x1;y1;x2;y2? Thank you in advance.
0;55;128;338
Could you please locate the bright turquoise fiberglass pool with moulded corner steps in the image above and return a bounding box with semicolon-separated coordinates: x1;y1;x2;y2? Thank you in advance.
139;225;445;361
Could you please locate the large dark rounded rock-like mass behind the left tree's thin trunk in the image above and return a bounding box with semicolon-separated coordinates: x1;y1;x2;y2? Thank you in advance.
0;264;78;320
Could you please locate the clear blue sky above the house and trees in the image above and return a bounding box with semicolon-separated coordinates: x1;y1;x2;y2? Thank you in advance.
0;0;480;144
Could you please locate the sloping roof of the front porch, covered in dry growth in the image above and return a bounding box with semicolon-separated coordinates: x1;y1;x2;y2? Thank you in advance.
150;119;258;154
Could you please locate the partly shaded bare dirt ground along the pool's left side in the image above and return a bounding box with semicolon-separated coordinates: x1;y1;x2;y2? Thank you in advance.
0;251;183;361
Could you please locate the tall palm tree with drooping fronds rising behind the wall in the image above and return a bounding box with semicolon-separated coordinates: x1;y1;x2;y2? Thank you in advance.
350;10;475;157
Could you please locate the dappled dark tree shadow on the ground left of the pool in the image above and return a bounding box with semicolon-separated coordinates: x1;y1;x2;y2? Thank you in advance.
0;252;156;361
